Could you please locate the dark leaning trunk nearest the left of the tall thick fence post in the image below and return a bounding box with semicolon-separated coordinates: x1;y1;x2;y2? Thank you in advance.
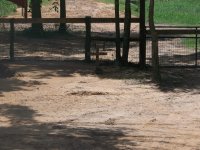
122;0;131;65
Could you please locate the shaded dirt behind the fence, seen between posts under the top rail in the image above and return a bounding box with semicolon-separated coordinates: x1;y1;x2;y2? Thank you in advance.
0;27;138;60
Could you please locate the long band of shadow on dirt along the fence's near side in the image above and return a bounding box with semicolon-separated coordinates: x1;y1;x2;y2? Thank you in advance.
0;61;200;93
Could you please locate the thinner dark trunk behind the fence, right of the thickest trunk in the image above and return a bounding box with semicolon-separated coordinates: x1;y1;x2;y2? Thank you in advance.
59;0;67;32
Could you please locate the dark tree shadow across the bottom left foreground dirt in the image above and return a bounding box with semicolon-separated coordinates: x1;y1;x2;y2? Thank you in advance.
0;104;140;150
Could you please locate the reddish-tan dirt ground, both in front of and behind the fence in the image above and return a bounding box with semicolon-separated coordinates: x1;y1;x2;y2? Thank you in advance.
0;0;200;150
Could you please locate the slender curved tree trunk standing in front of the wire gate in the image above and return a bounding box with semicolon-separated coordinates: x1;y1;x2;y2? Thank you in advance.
149;0;161;81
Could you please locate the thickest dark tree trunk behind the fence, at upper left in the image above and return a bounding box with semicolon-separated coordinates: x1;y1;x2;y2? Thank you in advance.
31;0;43;34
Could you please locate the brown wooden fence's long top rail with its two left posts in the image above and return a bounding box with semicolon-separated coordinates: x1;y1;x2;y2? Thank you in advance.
0;16;141;61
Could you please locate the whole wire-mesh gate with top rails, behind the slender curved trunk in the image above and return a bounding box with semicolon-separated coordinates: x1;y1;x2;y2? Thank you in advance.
146;26;200;67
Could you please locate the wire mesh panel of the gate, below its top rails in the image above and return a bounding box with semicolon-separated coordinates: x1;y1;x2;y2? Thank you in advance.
146;35;200;66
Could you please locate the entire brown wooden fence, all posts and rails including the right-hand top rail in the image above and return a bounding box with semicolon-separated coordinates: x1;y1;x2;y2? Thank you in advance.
0;16;200;64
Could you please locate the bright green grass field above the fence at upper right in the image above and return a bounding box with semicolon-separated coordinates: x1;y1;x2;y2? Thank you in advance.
98;0;200;25
